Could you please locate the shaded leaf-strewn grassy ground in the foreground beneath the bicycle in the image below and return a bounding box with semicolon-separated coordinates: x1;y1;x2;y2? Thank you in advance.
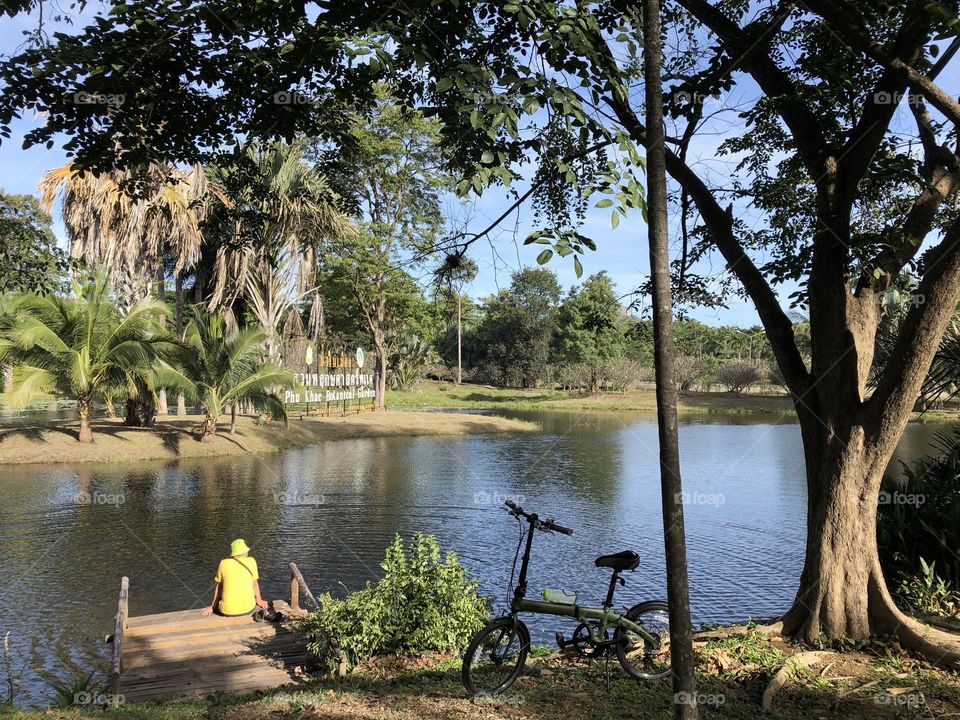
11;630;960;720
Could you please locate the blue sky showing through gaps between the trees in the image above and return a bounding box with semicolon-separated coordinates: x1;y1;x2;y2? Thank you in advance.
0;3;953;326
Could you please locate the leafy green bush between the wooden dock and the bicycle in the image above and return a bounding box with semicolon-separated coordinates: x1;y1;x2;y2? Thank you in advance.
298;533;489;669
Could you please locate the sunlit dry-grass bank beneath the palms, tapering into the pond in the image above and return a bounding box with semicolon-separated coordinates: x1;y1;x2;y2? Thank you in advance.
0;412;537;464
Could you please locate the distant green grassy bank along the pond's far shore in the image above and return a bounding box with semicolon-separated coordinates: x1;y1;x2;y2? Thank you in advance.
387;382;794;414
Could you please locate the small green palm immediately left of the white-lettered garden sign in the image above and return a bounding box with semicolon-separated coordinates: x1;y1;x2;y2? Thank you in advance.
180;313;294;442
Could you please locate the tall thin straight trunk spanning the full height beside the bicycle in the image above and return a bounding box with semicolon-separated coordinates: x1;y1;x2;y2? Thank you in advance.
643;0;697;720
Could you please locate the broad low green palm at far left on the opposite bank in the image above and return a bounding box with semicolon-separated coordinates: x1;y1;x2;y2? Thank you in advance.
0;273;176;442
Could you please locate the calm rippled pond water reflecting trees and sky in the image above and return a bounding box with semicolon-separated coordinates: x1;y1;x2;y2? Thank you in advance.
0;412;939;704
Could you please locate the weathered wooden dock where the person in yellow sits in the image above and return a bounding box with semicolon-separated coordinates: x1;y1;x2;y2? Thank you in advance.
110;563;316;703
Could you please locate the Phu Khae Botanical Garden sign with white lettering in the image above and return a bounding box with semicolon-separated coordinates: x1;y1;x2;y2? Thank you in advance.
284;342;376;413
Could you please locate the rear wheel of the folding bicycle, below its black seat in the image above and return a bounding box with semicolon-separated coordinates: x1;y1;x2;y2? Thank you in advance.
614;600;670;680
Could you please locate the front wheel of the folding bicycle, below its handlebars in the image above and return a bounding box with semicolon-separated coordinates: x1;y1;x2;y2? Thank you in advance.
461;617;530;697
